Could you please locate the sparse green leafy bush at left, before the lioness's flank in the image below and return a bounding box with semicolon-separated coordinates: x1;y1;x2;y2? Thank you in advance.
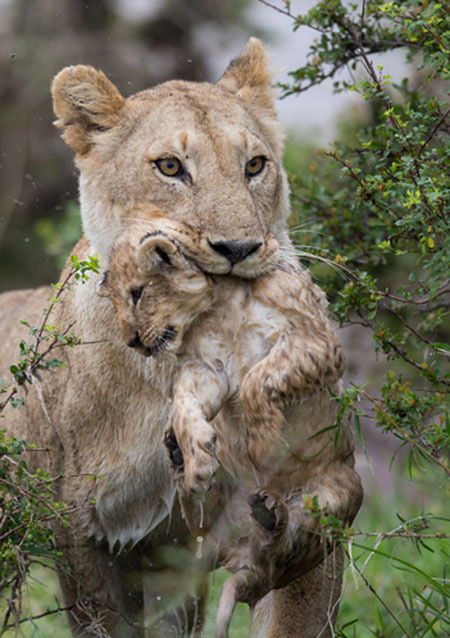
0;256;99;635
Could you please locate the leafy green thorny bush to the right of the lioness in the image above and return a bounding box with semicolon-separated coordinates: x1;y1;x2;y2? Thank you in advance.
261;0;450;637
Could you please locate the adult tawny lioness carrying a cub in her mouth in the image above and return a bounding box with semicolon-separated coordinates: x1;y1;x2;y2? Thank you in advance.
0;39;358;637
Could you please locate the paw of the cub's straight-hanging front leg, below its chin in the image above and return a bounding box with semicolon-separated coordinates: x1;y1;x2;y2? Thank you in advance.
184;425;219;495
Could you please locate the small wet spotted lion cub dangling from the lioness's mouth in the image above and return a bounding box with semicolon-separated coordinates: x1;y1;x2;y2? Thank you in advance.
100;220;362;636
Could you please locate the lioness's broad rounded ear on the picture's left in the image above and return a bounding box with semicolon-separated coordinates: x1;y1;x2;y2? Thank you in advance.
52;65;125;155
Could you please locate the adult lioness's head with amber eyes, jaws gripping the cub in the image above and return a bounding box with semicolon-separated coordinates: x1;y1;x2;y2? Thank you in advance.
52;38;288;277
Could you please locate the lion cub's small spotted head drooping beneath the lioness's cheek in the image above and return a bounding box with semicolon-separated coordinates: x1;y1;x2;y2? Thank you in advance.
98;220;212;357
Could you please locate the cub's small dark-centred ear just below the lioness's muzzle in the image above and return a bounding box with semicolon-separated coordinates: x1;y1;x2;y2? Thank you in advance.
137;235;186;276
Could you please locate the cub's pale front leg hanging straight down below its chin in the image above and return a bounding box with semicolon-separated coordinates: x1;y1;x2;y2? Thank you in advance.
171;360;228;493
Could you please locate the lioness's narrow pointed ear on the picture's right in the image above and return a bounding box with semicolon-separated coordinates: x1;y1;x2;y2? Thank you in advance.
217;38;276;116
